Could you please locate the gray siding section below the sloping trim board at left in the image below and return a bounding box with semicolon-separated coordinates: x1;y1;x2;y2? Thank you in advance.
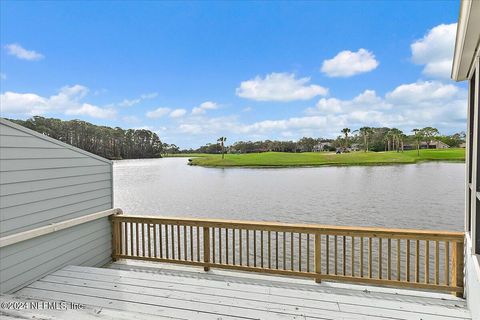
0;217;112;293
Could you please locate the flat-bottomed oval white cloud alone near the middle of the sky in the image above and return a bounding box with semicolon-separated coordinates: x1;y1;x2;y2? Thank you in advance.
236;73;328;102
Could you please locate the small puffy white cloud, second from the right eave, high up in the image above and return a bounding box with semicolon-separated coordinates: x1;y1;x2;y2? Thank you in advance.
321;49;379;78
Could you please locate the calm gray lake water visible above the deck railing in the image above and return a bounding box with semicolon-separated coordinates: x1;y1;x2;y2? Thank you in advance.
114;158;465;231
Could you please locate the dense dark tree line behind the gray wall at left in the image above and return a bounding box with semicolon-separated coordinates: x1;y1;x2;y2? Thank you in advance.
9;116;167;159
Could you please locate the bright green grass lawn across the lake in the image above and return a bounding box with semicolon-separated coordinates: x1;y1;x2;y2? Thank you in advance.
189;148;465;167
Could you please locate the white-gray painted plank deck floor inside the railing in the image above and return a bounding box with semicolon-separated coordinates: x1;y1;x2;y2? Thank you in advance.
0;262;470;320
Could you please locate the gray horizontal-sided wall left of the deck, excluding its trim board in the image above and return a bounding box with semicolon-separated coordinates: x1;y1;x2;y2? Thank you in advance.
0;118;113;293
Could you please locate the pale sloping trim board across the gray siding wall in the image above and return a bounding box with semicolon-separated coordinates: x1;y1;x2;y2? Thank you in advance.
0;208;122;248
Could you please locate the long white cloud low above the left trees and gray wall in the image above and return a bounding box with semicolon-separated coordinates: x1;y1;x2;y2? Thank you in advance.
0;84;116;119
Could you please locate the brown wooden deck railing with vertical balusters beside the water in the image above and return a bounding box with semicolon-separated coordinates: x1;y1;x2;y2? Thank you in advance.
112;215;464;295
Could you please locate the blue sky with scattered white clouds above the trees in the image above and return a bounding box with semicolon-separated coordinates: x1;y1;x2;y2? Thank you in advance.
0;1;466;147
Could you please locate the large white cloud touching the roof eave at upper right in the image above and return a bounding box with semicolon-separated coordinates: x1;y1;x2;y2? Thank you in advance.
410;23;457;79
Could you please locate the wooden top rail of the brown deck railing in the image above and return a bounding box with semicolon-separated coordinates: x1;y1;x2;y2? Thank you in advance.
112;215;464;242
